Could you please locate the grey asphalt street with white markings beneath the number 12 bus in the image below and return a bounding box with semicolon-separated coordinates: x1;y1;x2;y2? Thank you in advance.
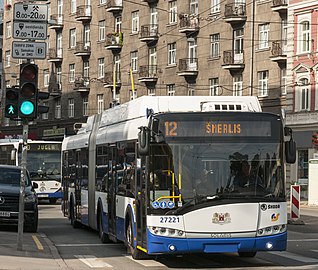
33;203;318;270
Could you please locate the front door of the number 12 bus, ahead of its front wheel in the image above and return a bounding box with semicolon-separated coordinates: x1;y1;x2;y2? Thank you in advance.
135;157;147;248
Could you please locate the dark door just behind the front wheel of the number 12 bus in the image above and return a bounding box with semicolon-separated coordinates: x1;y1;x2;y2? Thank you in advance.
107;147;117;236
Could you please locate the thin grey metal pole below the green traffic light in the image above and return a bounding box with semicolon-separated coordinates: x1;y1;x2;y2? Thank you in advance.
17;119;29;250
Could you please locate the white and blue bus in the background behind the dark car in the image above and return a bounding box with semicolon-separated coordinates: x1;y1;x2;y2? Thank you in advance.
0;139;62;203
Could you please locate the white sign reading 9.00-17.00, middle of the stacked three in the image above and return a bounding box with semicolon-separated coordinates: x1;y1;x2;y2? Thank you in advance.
13;21;47;40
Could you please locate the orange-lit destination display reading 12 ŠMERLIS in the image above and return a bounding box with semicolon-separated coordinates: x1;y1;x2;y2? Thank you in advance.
161;120;272;137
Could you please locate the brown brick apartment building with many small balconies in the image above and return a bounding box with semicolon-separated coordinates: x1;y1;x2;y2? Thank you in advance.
1;0;287;139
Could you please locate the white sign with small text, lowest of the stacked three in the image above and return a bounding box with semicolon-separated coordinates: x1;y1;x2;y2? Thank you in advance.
12;41;46;59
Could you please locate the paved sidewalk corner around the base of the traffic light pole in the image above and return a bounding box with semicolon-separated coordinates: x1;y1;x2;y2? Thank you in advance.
0;229;69;270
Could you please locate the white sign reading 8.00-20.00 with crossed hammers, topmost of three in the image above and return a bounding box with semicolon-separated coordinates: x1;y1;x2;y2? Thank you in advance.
13;3;48;22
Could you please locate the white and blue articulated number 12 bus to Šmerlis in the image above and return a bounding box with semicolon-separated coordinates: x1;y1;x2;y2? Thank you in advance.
62;96;296;259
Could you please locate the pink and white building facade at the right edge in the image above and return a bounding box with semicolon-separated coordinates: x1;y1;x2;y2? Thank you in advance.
286;0;318;197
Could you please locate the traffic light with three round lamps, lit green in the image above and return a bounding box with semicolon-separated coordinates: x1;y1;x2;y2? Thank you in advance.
18;63;38;120
